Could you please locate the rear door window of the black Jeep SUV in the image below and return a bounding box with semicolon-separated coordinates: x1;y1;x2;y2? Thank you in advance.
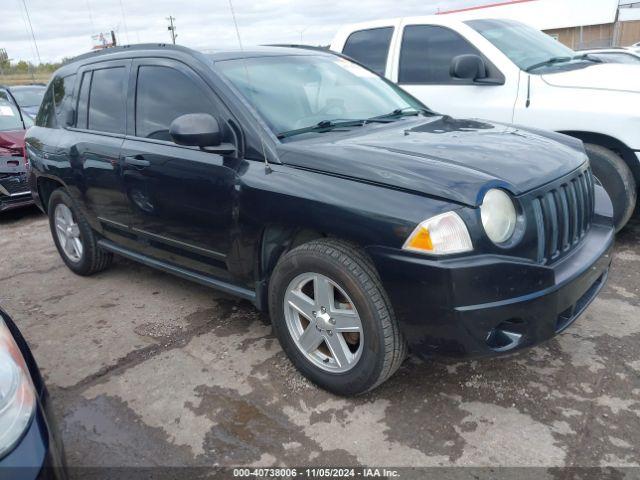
87;67;127;134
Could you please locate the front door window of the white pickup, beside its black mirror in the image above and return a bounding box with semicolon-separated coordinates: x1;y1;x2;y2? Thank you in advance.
398;25;479;84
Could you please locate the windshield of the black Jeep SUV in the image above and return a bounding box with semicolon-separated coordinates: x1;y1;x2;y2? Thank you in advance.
216;55;424;135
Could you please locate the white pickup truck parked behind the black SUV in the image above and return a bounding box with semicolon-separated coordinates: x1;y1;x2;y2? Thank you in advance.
331;15;640;230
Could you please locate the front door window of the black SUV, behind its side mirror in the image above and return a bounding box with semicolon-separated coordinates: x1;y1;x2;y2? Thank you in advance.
136;66;215;141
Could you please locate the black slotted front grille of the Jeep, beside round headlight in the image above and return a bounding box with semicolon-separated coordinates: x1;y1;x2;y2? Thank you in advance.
533;169;594;263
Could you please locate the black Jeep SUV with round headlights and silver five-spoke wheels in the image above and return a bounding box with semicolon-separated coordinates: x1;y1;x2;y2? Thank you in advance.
26;45;614;395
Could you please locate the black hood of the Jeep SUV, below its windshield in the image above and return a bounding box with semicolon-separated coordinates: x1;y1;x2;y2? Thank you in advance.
280;116;587;206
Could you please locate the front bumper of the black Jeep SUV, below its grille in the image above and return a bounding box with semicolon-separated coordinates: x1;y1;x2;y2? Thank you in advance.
369;220;614;357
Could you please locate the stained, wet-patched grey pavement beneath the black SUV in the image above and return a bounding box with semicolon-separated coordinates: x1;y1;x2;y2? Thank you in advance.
0;209;640;478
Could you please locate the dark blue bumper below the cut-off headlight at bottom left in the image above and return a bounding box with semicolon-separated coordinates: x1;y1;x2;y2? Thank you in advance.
0;396;67;480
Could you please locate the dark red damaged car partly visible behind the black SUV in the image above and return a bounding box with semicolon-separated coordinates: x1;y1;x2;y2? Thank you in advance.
0;87;33;212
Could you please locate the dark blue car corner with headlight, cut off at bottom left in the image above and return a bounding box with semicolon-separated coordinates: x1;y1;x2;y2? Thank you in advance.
0;308;67;480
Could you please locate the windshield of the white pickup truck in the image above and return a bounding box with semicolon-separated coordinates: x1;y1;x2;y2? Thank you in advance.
466;20;576;70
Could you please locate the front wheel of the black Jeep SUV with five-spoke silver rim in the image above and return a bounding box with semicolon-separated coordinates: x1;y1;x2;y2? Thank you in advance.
269;239;406;395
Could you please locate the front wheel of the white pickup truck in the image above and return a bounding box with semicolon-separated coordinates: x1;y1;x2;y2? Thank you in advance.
584;143;637;232
